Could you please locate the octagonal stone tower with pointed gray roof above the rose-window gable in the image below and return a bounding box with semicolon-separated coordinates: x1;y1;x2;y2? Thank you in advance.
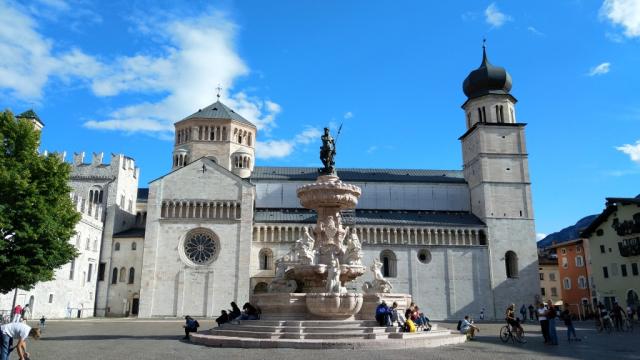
172;99;257;178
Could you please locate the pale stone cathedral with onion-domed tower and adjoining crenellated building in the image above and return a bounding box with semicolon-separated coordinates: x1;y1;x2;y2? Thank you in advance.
0;50;539;319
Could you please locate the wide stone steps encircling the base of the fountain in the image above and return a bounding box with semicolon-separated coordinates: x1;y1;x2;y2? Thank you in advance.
191;320;466;349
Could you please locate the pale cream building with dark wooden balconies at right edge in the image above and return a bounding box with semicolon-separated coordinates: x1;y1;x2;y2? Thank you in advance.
581;195;640;308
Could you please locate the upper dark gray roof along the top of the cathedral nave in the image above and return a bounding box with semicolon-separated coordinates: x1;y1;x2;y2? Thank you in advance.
251;166;466;183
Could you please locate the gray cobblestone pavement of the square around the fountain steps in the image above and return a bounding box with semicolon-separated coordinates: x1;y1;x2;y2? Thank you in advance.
23;319;640;360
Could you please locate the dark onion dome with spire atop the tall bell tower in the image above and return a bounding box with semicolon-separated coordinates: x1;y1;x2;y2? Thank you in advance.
462;46;511;99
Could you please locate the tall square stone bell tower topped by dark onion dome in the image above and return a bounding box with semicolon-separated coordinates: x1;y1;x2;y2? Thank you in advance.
460;46;539;316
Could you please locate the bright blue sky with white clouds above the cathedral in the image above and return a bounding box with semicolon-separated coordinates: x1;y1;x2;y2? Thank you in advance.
0;0;640;237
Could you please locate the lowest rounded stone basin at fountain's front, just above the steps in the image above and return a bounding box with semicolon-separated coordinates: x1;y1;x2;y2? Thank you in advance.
306;293;363;320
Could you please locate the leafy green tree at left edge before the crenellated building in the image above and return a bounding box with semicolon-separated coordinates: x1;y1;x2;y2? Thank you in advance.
0;111;80;293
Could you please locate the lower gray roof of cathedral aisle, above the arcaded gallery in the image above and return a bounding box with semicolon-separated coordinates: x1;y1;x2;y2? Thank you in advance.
254;209;485;227
